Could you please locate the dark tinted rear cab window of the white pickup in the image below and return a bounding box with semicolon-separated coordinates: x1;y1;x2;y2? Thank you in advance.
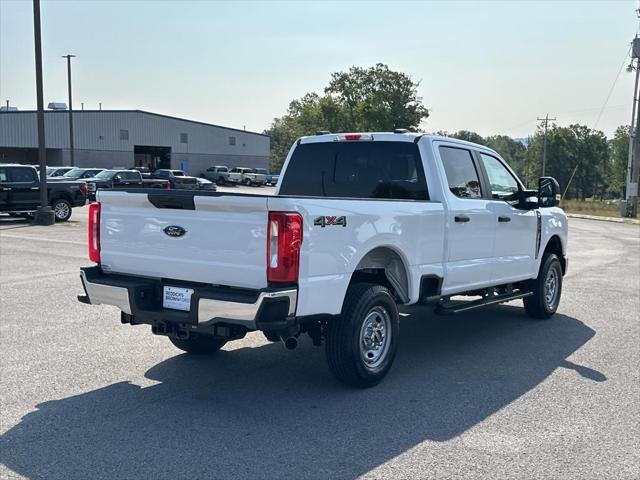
280;142;428;200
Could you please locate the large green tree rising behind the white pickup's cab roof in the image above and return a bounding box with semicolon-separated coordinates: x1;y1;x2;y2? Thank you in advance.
265;63;429;169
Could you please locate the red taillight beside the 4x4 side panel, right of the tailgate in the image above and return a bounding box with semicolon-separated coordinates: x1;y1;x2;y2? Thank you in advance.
267;212;302;283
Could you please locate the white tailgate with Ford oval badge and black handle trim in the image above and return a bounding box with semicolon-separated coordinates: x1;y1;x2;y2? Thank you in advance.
98;191;268;288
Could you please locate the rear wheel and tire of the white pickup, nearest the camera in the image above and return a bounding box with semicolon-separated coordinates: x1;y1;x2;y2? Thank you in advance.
325;283;400;388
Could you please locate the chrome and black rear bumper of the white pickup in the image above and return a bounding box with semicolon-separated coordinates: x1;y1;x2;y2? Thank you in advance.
80;266;298;330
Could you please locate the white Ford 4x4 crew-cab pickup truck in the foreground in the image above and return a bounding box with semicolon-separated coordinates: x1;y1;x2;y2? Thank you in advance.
79;132;567;387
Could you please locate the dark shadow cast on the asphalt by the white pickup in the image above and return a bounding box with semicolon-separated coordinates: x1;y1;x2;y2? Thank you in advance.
0;306;606;479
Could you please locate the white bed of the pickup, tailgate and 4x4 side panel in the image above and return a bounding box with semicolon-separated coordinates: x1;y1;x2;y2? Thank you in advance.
98;189;444;314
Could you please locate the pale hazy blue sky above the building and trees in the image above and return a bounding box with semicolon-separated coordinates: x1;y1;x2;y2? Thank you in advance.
0;0;638;137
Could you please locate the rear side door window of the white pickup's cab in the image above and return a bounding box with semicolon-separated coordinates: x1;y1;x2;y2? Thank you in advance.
440;147;482;198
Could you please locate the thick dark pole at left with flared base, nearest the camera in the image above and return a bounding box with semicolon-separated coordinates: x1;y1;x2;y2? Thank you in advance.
33;0;55;225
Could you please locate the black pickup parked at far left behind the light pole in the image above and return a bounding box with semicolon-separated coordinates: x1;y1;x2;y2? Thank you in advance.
0;164;87;222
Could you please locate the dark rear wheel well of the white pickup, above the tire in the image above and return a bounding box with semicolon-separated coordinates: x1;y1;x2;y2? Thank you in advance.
349;247;409;303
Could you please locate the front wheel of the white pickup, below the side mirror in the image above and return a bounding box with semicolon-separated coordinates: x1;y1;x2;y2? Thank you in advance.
523;253;562;319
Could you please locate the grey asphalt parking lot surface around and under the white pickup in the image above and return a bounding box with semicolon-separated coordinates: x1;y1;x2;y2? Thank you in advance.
0;194;640;479
